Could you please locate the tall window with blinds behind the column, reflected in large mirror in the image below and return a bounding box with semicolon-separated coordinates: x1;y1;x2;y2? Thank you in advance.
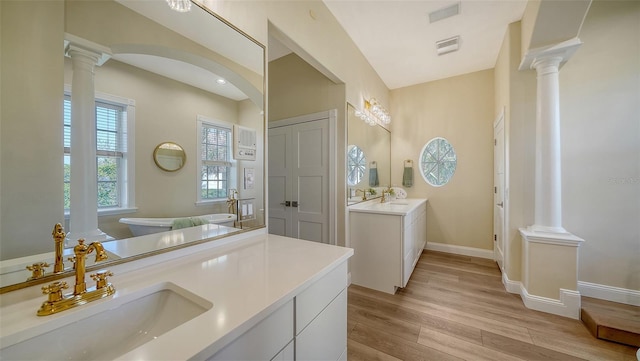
64;94;127;209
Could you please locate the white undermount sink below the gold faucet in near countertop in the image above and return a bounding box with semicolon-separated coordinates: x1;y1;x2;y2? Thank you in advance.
0;283;213;360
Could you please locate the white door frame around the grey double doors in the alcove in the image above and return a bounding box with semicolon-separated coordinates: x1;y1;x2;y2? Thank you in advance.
265;109;338;245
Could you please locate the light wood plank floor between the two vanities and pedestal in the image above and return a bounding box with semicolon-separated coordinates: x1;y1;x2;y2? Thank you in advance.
347;251;637;361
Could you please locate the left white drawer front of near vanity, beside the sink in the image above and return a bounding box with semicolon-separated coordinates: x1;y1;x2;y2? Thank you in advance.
209;300;294;361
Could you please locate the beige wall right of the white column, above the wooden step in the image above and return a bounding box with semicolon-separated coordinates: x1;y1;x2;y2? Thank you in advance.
560;1;640;290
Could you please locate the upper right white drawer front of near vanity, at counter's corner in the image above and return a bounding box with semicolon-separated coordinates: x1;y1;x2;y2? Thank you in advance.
296;262;347;335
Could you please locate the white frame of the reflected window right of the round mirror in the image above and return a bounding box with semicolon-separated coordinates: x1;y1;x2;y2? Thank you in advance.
196;115;237;206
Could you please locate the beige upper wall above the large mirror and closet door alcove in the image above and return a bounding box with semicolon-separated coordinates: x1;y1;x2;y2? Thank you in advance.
203;0;389;114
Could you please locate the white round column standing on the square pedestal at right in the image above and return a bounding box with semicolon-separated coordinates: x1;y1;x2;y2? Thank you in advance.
531;56;566;233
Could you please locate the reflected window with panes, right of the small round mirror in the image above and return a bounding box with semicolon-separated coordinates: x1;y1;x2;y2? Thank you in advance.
198;116;233;202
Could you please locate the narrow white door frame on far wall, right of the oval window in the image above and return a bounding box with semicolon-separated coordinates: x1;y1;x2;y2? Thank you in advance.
493;107;509;273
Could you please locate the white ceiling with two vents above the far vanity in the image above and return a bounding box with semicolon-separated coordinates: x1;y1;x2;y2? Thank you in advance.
323;0;527;89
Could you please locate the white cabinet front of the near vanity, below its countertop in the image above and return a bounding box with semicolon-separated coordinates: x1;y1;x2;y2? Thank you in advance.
209;262;347;361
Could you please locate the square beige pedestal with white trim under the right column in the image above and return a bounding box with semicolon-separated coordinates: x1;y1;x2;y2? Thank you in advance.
520;228;584;319
